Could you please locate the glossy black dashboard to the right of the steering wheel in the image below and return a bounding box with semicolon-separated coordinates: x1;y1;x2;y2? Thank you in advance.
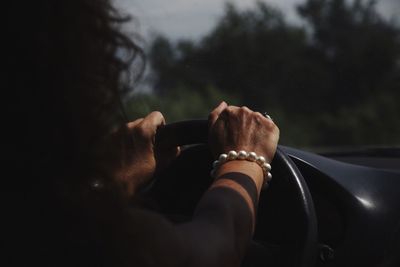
284;147;400;266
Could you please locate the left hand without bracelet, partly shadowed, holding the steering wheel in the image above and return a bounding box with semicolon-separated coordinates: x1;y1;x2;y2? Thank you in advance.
117;111;179;195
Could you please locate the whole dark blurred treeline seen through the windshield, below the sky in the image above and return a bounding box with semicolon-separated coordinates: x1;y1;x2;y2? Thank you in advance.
132;0;400;146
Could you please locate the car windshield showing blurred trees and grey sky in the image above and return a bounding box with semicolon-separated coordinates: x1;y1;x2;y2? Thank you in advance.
116;0;400;150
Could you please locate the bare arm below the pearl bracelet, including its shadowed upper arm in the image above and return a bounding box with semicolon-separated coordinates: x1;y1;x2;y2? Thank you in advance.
120;161;263;267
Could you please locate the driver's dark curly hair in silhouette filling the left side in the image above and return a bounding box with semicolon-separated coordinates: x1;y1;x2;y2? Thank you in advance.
2;0;144;266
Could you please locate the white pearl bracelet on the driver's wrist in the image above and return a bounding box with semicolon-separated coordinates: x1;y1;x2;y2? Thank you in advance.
211;150;272;187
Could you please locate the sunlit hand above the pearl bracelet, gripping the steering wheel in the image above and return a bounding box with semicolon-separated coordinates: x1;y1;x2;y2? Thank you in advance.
209;102;279;162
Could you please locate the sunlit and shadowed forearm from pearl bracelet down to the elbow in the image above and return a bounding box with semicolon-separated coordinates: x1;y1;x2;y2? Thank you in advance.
179;161;263;266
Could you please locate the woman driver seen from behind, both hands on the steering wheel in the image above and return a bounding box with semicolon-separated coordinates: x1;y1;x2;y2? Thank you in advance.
2;0;279;267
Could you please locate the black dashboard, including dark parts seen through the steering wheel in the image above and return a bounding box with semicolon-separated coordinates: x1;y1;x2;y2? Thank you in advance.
149;140;400;267
